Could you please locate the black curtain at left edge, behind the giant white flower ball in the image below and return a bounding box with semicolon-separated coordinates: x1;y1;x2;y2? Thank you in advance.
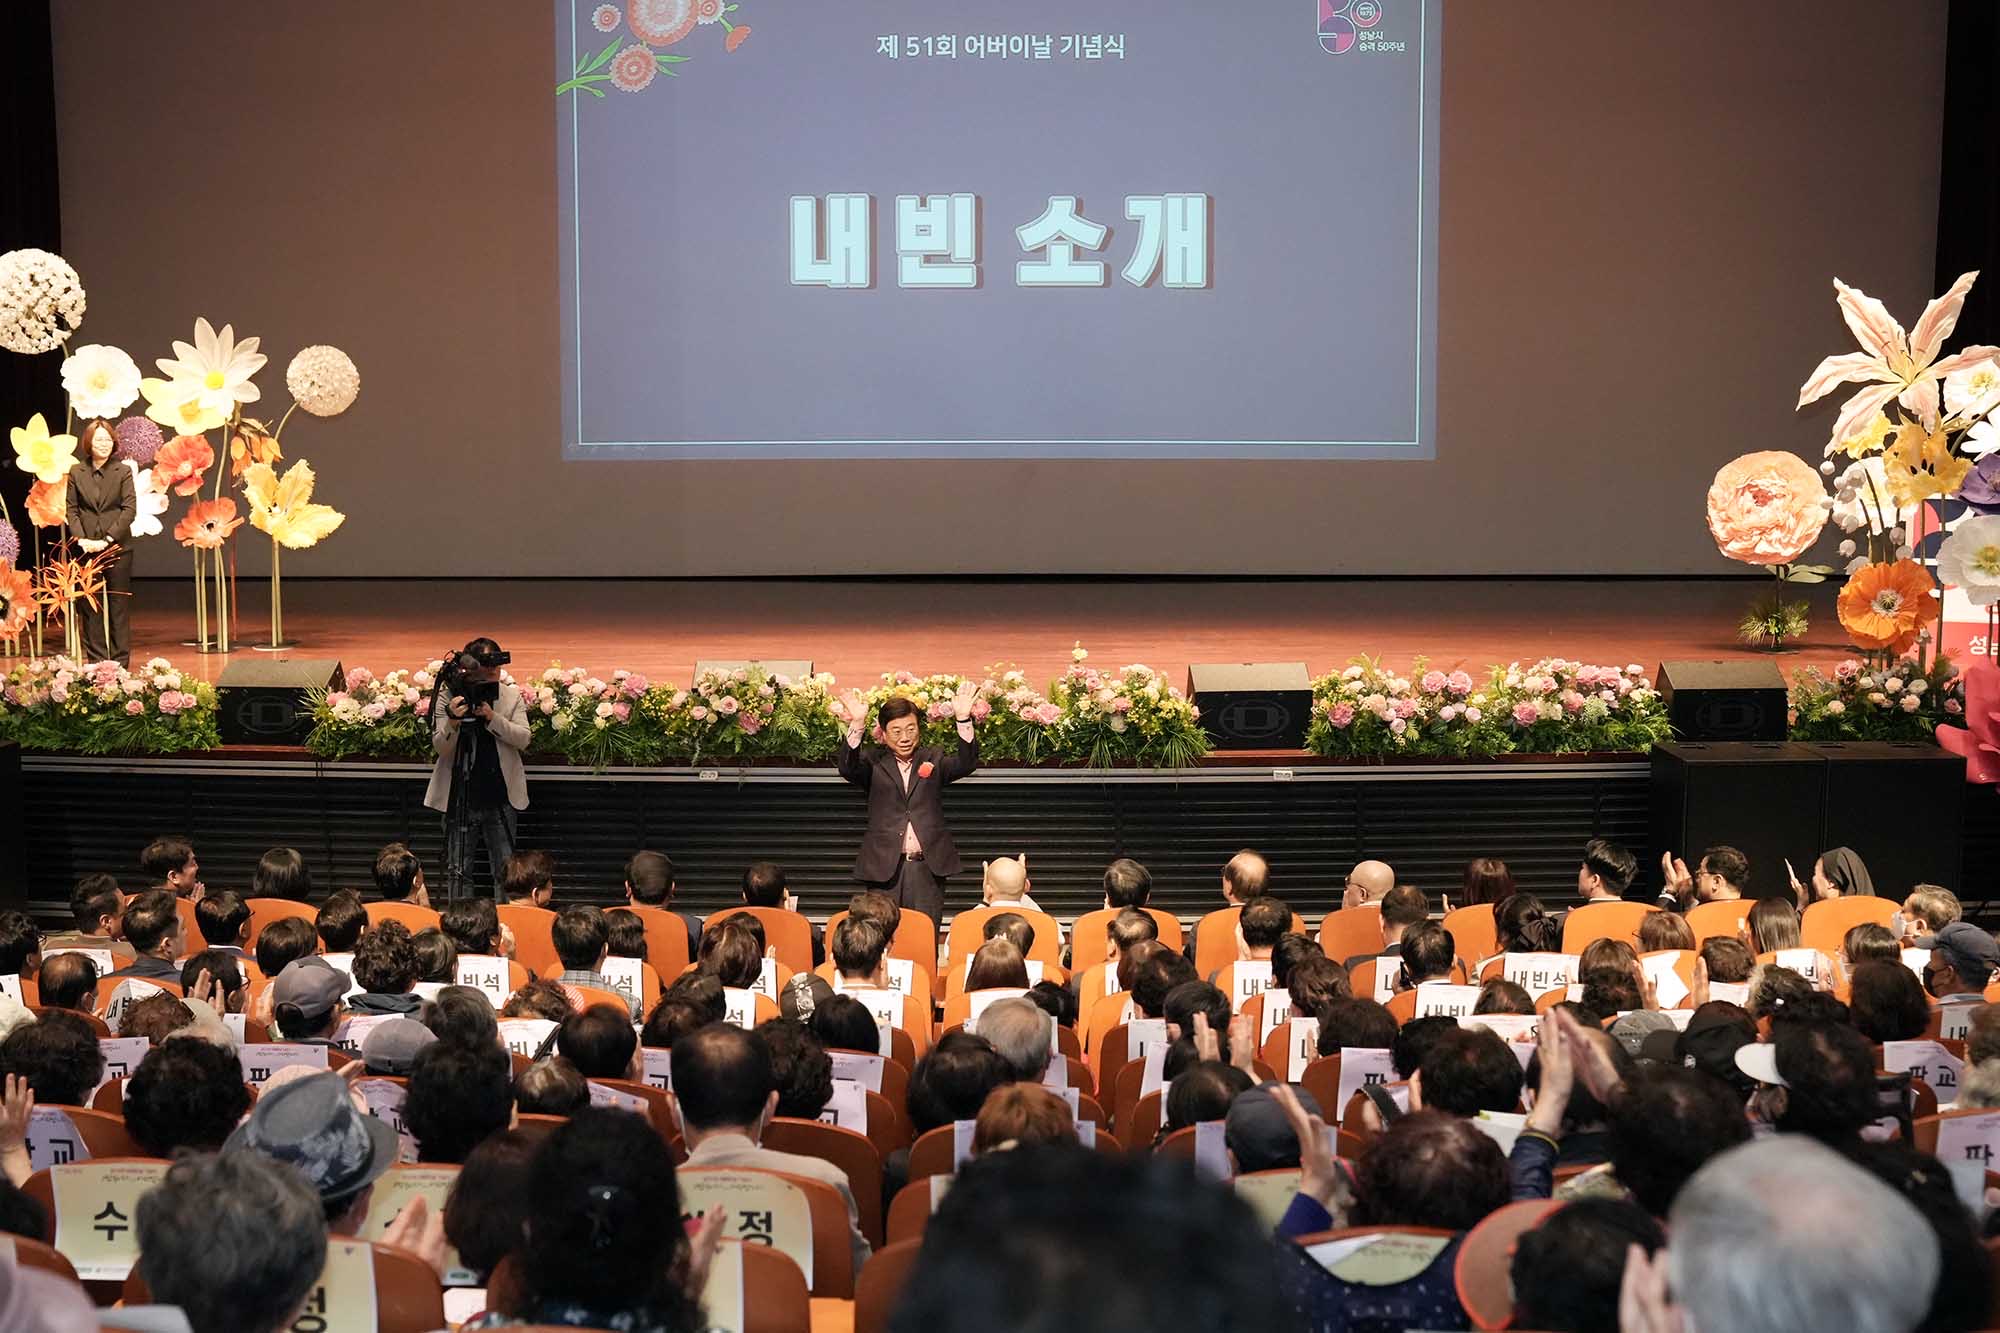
0;0;60;536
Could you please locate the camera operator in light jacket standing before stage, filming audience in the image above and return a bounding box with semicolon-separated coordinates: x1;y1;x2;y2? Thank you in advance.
424;638;528;899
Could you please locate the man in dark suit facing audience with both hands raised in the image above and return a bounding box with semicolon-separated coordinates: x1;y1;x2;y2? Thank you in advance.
838;685;980;925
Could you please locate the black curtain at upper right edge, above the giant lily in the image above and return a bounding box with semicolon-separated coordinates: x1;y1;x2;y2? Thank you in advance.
1932;0;2000;348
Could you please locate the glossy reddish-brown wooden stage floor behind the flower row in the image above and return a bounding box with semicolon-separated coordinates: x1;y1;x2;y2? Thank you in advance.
78;578;1848;685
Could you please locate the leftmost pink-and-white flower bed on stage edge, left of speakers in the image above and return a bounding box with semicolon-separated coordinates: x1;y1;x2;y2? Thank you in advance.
0;656;222;755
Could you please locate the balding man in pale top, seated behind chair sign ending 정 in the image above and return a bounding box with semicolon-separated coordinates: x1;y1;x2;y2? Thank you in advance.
674;1023;870;1273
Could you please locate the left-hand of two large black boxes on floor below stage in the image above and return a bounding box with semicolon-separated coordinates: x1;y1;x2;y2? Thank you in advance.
1634;741;1824;899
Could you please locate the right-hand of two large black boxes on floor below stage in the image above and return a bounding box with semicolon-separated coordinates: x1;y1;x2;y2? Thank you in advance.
1794;741;1960;903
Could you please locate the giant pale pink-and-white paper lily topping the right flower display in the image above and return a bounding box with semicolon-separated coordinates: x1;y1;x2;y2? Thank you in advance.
1798;270;2000;454
